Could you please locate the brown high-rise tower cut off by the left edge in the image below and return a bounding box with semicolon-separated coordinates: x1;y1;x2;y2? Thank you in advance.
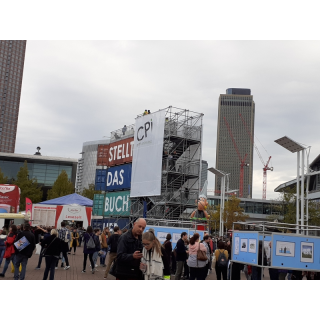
0;40;27;153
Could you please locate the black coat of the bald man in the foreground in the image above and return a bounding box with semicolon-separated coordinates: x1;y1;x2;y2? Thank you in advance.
115;229;142;280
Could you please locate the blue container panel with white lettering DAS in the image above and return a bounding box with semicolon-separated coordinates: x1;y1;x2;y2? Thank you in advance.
107;163;132;191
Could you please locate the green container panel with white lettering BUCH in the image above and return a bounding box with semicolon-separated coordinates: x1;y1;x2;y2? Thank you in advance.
104;191;130;217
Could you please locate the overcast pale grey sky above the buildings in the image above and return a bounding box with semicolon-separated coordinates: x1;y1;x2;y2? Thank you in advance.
15;41;320;199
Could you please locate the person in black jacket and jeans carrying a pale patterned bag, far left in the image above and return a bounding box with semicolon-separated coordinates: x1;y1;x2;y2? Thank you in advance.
14;223;36;280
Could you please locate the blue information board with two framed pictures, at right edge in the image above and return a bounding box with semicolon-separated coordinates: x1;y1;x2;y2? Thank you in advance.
271;233;320;271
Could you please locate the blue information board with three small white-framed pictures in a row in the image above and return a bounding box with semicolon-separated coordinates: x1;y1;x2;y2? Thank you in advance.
232;231;259;265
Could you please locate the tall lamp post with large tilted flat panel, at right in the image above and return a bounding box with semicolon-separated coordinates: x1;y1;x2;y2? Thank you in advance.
274;136;309;233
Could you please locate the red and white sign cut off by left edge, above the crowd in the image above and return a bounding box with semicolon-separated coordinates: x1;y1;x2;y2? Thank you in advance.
0;184;20;213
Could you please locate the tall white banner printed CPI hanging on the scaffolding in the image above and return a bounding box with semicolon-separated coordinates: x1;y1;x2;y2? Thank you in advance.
130;110;166;197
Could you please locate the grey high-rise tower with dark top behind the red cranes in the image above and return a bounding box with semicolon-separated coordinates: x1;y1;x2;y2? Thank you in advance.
215;88;255;198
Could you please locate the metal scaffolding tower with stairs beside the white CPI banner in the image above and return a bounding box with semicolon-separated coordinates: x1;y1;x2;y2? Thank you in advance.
109;106;203;227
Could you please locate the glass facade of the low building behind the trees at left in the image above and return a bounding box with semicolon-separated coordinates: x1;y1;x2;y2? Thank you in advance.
0;160;74;187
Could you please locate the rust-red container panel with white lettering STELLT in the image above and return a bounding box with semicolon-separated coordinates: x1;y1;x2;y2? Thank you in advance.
97;138;133;167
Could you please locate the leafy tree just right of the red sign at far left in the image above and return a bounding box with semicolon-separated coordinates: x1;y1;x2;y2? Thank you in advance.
14;161;42;211
